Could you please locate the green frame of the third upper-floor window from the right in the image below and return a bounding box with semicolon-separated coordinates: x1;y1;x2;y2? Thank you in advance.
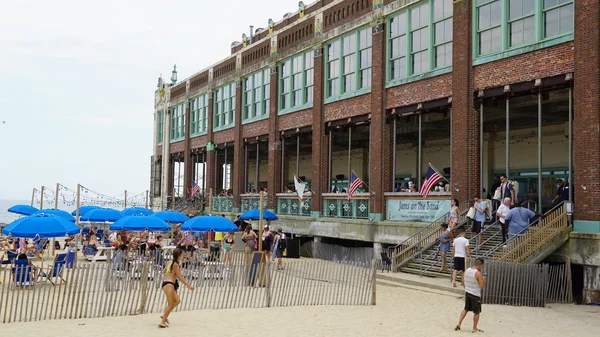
324;26;373;103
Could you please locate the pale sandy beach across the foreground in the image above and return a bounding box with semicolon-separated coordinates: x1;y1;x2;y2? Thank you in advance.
2;285;600;337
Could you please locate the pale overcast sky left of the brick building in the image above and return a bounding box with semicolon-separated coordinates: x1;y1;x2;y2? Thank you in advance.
0;0;300;200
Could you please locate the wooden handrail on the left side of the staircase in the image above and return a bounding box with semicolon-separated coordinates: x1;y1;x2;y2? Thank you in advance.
390;201;471;271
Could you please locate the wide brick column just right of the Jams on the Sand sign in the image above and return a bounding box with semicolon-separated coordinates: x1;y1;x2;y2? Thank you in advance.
450;1;483;202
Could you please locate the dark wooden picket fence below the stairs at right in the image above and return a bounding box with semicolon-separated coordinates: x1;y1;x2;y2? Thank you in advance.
482;260;573;307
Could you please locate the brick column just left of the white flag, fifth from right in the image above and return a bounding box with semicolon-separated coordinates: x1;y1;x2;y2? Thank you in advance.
267;66;281;210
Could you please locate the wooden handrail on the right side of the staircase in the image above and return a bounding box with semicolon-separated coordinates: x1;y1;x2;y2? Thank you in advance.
484;202;569;263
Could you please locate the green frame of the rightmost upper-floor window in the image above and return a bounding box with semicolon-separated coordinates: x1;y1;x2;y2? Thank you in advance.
472;0;574;61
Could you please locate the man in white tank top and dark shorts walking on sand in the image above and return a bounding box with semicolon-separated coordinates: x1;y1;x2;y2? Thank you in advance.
454;258;486;333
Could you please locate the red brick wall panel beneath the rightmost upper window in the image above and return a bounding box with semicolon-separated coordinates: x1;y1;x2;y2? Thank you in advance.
474;42;574;90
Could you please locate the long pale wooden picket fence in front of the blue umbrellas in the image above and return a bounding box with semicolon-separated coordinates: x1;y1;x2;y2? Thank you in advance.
0;252;375;323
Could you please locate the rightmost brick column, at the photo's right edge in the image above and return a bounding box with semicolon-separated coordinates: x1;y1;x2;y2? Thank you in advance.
569;0;600;233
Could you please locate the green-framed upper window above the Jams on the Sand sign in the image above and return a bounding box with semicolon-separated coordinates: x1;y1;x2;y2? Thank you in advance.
386;0;453;85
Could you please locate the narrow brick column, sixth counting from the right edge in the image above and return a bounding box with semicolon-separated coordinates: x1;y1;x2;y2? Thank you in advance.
231;81;245;213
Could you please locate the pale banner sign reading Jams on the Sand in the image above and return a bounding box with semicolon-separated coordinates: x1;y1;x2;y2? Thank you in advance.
386;199;450;222
